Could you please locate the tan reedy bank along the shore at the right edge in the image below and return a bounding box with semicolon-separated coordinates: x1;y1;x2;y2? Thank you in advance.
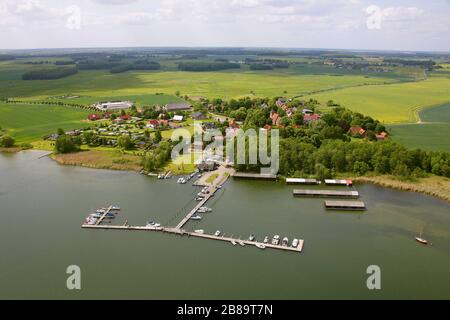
347;176;450;202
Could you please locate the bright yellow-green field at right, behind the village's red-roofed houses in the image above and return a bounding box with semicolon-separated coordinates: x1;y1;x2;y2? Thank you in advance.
309;75;450;123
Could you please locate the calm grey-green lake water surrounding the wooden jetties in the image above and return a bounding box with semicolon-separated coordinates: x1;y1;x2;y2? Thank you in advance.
0;151;450;299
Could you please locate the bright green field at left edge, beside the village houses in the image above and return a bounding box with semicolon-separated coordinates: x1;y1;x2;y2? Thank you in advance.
0;103;90;144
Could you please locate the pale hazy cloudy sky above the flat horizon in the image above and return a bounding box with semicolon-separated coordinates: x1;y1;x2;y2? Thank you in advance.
0;0;450;51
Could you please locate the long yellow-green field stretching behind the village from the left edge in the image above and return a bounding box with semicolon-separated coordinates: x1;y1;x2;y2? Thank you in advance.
0;64;399;103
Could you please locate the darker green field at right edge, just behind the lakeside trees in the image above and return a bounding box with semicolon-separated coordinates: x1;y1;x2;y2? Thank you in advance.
388;123;450;151
